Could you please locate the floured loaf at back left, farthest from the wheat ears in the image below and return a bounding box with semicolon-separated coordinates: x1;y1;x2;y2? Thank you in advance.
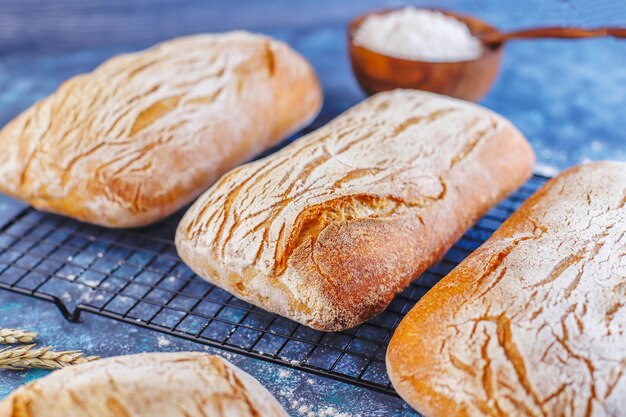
0;32;322;227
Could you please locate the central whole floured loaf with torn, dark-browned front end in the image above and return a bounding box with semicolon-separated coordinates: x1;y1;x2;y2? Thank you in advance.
176;90;534;331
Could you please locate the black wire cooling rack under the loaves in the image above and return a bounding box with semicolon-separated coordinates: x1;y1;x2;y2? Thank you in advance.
0;176;546;394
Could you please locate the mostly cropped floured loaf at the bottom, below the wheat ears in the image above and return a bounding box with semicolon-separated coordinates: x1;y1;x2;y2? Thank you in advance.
0;353;287;417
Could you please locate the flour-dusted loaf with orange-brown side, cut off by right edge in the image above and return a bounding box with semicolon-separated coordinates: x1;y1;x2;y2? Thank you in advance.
387;162;626;417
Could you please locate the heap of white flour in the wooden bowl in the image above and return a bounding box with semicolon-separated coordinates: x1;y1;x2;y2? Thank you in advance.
354;7;482;62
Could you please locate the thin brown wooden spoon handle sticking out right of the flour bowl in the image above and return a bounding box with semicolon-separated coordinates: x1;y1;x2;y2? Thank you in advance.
479;26;626;45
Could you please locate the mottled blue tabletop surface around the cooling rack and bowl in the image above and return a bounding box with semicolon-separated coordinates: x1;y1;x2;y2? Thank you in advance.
0;0;626;417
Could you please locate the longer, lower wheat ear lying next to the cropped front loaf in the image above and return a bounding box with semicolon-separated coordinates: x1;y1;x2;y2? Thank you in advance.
0;345;98;371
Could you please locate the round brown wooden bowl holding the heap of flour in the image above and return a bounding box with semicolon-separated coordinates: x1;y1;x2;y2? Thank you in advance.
348;9;503;101
